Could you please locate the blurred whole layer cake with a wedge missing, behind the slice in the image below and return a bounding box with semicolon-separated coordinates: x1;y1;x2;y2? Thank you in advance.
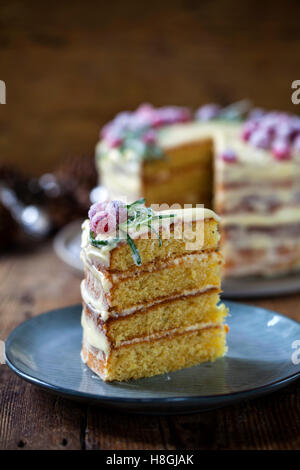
96;105;300;276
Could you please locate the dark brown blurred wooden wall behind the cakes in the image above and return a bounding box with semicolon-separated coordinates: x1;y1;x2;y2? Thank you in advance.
0;0;300;174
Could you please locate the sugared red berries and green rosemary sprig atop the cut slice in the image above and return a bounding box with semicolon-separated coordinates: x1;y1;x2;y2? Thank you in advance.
89;198;175;266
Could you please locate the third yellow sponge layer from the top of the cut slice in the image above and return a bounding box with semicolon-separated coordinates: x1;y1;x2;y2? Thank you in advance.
83;289;227;347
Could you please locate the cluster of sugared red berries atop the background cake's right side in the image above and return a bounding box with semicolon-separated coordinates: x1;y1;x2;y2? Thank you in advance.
242;110;300;160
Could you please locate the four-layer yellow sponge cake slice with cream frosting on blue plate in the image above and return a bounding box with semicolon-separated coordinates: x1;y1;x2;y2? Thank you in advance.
81;196;227;381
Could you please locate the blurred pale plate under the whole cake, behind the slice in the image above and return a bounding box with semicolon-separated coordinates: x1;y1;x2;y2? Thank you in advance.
54;220;300;299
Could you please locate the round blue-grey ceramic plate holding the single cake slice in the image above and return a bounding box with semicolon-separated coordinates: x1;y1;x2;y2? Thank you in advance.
6;302;300;414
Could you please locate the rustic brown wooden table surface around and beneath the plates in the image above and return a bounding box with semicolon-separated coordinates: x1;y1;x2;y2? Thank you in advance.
0;244;300;450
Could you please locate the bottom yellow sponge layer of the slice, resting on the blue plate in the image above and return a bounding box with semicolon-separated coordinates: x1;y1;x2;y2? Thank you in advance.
82;325;227;381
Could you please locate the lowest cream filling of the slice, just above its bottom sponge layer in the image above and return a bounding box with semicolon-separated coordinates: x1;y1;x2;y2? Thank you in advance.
81;312;224;357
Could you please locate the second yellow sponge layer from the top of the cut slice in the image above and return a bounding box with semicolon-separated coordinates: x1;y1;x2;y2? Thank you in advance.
85;251;222;313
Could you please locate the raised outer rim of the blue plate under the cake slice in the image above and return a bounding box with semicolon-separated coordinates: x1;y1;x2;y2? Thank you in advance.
5;301;300;405
